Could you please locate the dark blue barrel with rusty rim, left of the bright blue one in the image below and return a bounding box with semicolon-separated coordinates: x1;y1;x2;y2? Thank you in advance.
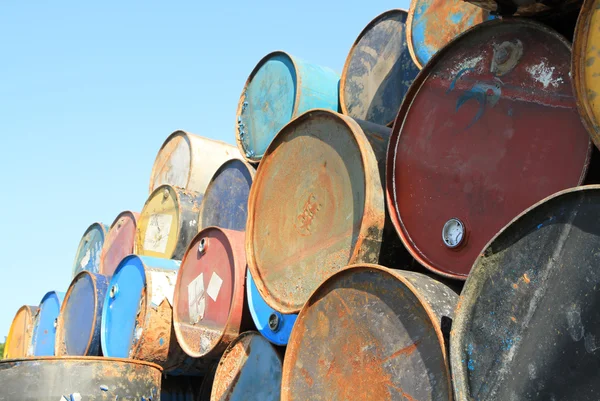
54;271;108;356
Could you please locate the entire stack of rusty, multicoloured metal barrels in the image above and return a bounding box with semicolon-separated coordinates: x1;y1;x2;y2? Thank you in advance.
0;0;600;401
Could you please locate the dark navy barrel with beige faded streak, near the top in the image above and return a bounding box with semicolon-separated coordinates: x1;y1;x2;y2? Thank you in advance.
340;10;419;125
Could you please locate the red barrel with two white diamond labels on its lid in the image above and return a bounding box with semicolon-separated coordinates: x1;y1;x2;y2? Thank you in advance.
173;227;250;366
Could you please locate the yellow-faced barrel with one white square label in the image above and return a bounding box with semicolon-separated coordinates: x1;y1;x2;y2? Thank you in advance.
135;185;202;260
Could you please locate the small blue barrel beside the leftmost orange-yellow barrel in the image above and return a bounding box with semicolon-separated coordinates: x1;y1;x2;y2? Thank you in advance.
30;291;65;356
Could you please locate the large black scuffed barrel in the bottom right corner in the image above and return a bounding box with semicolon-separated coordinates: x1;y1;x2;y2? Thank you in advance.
450;185;600;401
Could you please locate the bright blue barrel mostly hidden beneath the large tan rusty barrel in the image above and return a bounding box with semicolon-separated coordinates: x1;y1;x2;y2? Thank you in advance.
246;270;298;345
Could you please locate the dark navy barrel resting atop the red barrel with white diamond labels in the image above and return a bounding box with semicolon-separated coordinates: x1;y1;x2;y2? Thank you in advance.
198;159;256;231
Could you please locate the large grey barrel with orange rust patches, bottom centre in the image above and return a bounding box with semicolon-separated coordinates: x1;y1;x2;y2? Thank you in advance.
281;264;458;401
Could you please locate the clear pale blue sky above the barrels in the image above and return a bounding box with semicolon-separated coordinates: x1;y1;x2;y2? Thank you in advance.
0;0;409;341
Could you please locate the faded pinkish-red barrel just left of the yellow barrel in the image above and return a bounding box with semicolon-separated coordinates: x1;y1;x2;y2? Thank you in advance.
100;211;140;277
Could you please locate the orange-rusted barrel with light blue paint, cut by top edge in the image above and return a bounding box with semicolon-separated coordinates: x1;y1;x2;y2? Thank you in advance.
406;0;494;68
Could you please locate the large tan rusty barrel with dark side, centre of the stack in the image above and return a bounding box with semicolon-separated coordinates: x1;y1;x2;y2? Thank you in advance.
246;110;390;313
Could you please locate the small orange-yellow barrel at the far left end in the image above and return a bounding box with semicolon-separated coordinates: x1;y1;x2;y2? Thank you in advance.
2;305;38;359
